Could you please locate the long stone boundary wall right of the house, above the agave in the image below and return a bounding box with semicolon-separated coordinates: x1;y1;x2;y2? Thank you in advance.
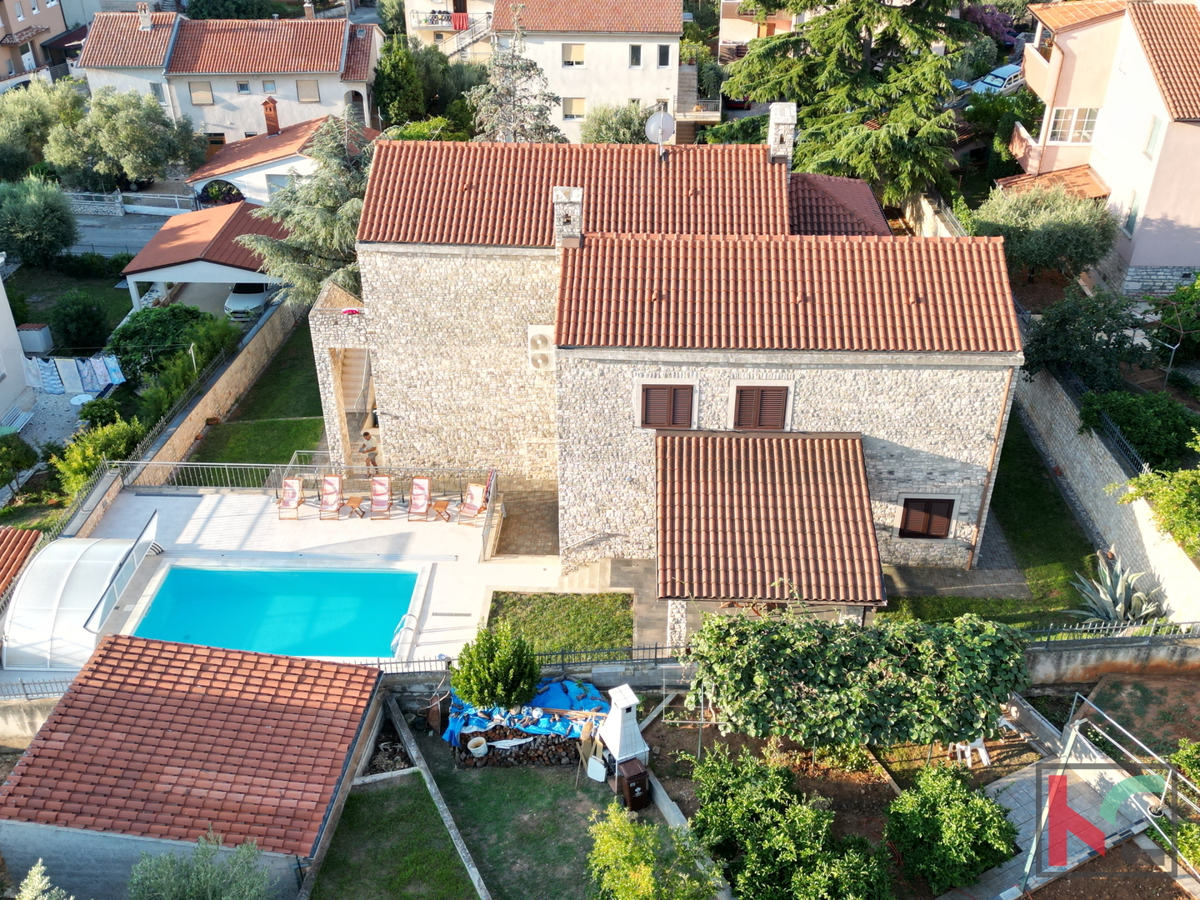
1014;372;1200;622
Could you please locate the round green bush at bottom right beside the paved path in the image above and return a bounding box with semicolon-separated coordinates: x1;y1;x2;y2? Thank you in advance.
887;766;1016;896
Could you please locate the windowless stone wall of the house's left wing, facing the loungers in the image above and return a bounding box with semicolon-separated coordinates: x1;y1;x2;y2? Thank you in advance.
311;245;558;479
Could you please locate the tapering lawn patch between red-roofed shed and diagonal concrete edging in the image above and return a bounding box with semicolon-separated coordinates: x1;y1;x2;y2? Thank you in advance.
312;773;475;900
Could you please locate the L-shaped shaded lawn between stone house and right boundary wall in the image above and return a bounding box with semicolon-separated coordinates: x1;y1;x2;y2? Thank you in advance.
883;415;1096;628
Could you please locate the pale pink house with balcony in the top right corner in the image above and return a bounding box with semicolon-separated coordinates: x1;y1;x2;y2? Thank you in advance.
1013;0;1200;294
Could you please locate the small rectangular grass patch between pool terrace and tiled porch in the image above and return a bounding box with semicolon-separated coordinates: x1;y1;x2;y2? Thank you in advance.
487;592;634;652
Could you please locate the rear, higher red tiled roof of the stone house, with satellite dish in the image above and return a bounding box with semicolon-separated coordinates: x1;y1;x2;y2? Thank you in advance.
359;140;788;247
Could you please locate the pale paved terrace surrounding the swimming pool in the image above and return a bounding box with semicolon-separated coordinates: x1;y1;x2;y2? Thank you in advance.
90;488;559;659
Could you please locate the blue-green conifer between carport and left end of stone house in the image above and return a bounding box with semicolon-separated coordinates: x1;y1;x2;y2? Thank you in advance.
238;116;373;302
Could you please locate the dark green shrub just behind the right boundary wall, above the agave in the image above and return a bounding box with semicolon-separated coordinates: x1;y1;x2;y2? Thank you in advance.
1079;391;1200;468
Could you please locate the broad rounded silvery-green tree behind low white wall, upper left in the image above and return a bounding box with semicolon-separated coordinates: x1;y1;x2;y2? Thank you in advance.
46;86;205;191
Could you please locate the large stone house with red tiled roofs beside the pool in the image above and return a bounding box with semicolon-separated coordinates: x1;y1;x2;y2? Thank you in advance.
310;104;1022;606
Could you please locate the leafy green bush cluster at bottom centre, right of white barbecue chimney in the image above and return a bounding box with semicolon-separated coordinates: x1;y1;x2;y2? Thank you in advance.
691;745;892;900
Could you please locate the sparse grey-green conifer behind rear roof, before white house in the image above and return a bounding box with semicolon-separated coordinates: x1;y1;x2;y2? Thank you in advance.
466;25;566;144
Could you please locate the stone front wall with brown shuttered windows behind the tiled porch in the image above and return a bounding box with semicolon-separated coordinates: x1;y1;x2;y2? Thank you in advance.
557;350;1020;569
